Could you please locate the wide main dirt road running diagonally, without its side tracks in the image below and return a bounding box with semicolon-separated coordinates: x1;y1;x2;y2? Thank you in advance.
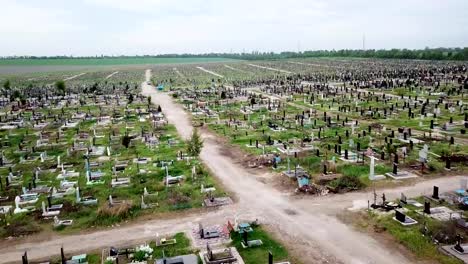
142;71;409;263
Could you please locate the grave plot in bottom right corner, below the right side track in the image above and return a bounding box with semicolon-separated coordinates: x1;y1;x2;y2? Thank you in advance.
354;183;468;263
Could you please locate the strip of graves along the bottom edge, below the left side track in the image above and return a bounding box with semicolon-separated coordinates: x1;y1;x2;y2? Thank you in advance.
18;221;290;264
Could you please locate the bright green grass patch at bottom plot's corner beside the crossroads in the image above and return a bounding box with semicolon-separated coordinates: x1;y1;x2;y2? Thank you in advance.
231;226;289;264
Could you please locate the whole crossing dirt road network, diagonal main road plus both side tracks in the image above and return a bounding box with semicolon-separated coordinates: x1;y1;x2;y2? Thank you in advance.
0;68;458;264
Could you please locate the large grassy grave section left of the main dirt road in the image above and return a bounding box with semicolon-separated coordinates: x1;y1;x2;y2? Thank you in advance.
0;84;232;236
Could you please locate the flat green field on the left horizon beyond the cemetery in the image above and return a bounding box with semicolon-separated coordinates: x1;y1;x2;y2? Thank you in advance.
0;57;235;66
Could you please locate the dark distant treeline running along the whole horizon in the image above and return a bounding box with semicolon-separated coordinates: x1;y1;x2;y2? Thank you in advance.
0;47;468;61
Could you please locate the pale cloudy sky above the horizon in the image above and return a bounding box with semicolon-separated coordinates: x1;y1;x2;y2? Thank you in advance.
0;0;468;56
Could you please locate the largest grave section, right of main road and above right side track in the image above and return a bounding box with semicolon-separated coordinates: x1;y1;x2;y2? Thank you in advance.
169;57;468;195
